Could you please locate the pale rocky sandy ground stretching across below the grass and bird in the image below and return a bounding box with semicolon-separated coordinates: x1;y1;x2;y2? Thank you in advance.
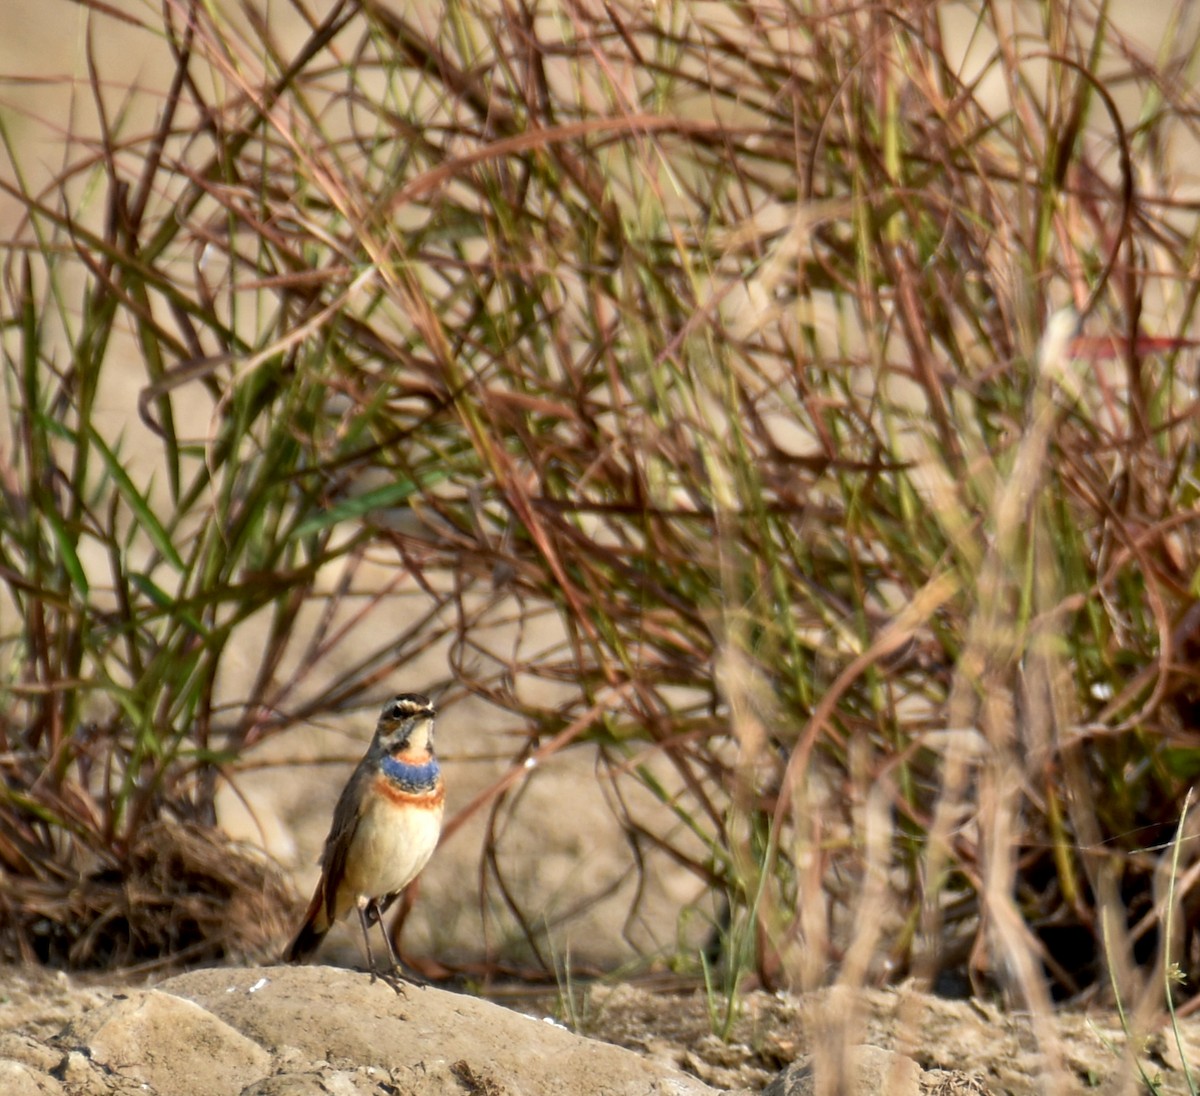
0;966;1200;1096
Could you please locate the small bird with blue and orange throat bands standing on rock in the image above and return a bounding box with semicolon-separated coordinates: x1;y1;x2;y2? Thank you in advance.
283;693;445;978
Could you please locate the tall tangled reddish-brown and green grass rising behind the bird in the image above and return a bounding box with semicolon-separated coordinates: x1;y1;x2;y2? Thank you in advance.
0;0;1200;1002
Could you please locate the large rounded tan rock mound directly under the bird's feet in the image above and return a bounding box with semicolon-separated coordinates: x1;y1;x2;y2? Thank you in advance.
0;966;716;1096
